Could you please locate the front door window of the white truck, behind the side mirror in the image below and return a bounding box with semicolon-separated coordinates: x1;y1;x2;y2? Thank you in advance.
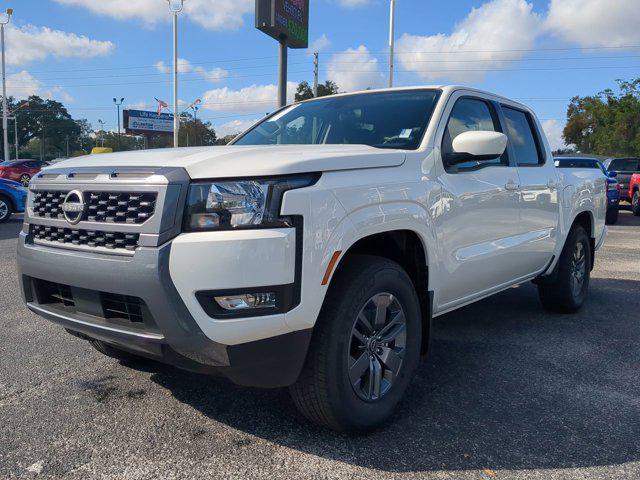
442;97;507;171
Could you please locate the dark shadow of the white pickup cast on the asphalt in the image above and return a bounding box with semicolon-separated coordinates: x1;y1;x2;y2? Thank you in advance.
152;279;640;472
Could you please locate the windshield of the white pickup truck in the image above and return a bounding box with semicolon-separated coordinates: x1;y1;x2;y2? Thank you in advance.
233;90;440;150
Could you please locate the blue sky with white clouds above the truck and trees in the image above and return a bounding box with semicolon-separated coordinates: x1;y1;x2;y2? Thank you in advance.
5;0;640;146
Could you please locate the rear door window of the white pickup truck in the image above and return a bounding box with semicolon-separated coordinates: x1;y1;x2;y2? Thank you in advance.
502;106;544;166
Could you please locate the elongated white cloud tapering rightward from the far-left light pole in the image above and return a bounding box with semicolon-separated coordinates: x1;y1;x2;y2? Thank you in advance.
6;25;114;65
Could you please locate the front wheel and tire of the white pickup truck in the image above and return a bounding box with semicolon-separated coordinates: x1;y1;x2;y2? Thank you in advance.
290;255;422;431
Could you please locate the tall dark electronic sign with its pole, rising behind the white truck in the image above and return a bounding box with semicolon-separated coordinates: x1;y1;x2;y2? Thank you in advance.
256;0;309;107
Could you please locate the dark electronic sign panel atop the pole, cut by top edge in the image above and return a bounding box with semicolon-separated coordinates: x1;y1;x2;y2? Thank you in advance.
256;0;309;48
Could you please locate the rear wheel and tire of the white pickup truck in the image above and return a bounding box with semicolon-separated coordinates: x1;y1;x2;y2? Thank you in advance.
538;225;591;313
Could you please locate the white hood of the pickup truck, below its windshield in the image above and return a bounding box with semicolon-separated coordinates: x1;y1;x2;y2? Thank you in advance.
53;145;406;179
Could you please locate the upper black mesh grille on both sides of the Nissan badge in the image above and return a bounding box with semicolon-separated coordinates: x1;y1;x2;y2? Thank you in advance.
33;190;158;225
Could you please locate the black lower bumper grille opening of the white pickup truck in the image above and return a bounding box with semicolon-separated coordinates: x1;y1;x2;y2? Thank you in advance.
32;279;157;331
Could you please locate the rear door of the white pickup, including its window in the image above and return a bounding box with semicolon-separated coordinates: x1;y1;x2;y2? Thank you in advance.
501;104;560;273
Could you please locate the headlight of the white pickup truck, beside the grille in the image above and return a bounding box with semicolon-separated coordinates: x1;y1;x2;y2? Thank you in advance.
184;174;319;231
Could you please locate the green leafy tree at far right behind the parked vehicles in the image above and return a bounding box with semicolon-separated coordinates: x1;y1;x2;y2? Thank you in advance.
563;78;640;156
